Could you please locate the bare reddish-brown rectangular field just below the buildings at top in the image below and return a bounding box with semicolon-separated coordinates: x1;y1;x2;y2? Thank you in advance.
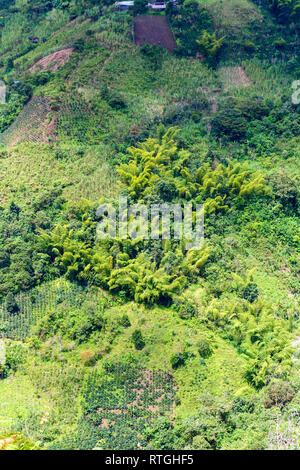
134;15;177;52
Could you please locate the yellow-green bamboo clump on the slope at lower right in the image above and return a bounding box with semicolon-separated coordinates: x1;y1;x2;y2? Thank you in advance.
204;299;292;387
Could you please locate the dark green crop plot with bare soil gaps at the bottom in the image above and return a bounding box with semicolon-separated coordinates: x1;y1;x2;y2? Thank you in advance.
59;366;175;450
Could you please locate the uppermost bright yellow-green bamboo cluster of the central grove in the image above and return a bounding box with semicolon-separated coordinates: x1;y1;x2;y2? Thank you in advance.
118;128;270;213
